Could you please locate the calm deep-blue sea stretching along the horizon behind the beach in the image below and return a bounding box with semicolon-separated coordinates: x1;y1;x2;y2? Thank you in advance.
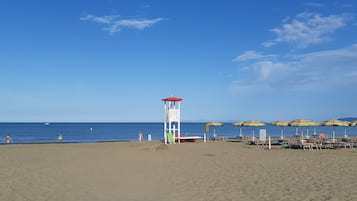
0;122;357;144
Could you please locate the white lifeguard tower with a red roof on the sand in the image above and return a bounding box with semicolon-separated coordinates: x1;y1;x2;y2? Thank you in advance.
162;96;183;144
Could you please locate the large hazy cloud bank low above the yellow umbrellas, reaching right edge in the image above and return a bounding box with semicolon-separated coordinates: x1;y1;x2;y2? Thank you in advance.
231;44;357;91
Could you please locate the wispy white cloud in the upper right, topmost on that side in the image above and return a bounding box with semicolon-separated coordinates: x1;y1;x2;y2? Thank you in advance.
262;12;353;48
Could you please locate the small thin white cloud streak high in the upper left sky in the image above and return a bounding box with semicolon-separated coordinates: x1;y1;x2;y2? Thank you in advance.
80;15;164;34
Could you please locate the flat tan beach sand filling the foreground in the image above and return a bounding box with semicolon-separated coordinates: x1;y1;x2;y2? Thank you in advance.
0;142;357;201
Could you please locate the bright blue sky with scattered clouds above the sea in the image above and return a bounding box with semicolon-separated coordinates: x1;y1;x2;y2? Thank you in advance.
0;0;357;122
